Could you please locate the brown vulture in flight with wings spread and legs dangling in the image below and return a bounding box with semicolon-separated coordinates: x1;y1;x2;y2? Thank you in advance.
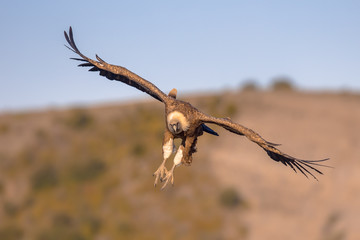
64;26;329;189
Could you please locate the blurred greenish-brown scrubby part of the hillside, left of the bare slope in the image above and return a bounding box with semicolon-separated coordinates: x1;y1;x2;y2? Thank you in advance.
0;99;249;240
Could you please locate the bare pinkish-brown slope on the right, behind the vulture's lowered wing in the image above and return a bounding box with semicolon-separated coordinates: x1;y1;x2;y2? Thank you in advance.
207;92;360;239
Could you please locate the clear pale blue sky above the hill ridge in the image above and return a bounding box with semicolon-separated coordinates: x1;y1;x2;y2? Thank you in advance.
0;0;360;111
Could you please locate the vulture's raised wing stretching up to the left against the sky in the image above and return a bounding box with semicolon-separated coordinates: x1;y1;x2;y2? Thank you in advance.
64;27;168;102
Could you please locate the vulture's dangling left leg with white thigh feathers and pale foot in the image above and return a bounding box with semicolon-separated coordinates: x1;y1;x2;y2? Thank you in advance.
153;129;175;187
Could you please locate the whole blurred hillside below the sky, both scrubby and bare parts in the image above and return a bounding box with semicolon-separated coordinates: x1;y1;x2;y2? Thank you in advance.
0;91;360;240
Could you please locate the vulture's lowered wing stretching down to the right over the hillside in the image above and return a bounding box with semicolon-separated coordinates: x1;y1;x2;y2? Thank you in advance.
201;114;329;180
